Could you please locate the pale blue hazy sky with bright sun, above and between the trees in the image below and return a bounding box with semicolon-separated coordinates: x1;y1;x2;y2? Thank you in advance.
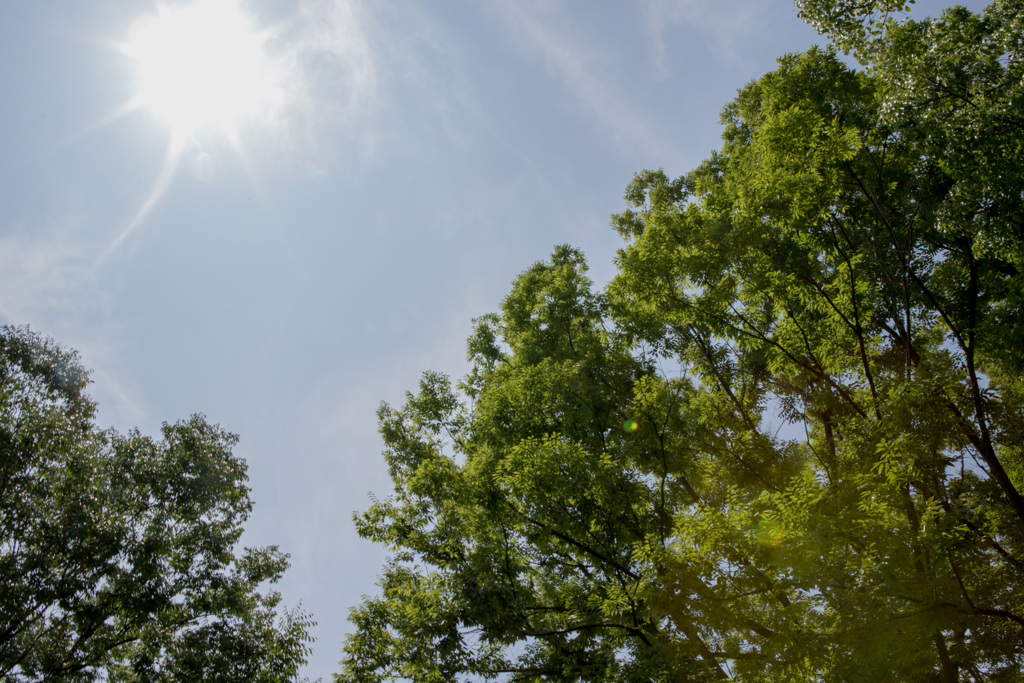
0;0;980;682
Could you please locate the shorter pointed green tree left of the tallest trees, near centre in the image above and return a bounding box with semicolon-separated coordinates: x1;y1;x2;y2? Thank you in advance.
344;248;680;681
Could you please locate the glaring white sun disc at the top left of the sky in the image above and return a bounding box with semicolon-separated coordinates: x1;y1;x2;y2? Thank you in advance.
123;0;280;140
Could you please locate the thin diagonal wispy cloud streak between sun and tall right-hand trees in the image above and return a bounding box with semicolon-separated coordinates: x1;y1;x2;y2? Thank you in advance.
493;0;662;155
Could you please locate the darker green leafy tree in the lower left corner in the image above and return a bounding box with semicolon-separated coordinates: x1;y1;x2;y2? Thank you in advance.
0;327;312;682
